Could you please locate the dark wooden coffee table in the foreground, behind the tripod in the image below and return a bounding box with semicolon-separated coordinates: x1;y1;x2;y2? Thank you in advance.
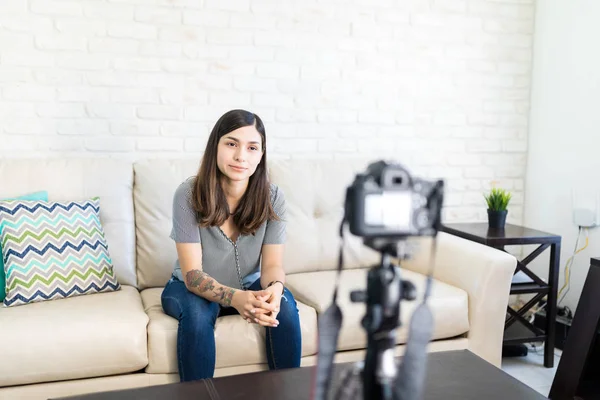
54;350;546;400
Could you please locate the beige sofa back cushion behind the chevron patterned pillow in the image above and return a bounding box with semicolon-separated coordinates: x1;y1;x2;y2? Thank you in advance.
0;157;137;286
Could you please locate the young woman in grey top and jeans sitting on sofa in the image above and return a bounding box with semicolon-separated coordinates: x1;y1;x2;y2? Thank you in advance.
162;110;301;382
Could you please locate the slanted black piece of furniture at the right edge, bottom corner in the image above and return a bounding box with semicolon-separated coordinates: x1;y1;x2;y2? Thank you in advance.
550;258;600;400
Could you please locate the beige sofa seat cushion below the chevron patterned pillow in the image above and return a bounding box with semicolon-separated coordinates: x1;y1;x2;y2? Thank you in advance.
0;285;148;387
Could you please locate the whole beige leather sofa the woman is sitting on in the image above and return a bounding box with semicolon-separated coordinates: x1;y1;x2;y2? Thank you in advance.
0;158;516;399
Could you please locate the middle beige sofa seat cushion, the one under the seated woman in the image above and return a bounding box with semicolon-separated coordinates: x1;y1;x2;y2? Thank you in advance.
141;288;317;374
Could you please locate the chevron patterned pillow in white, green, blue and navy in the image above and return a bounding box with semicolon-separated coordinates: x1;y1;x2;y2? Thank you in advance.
0;197;120;307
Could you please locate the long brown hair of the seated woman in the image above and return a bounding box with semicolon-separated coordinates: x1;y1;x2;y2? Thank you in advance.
192;110;279;235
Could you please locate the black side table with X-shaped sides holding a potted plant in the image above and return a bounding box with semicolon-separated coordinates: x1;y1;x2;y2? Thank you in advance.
442;223;561;368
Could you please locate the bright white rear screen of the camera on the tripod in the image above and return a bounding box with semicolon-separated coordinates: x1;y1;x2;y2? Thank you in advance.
365;192;412;231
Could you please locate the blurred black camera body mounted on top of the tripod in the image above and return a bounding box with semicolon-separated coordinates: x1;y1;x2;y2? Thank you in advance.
345;161;444;240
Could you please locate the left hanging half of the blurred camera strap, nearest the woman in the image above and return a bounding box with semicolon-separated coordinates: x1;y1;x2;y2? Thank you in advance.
311;218;346;400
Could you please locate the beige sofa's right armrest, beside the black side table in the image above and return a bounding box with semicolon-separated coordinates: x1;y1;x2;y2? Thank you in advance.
402;232;517;367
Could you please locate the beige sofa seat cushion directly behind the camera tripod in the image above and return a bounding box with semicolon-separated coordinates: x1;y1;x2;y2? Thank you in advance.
286;268;469;350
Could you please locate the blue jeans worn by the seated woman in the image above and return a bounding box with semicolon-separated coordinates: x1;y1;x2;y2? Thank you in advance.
161;278;302;382
